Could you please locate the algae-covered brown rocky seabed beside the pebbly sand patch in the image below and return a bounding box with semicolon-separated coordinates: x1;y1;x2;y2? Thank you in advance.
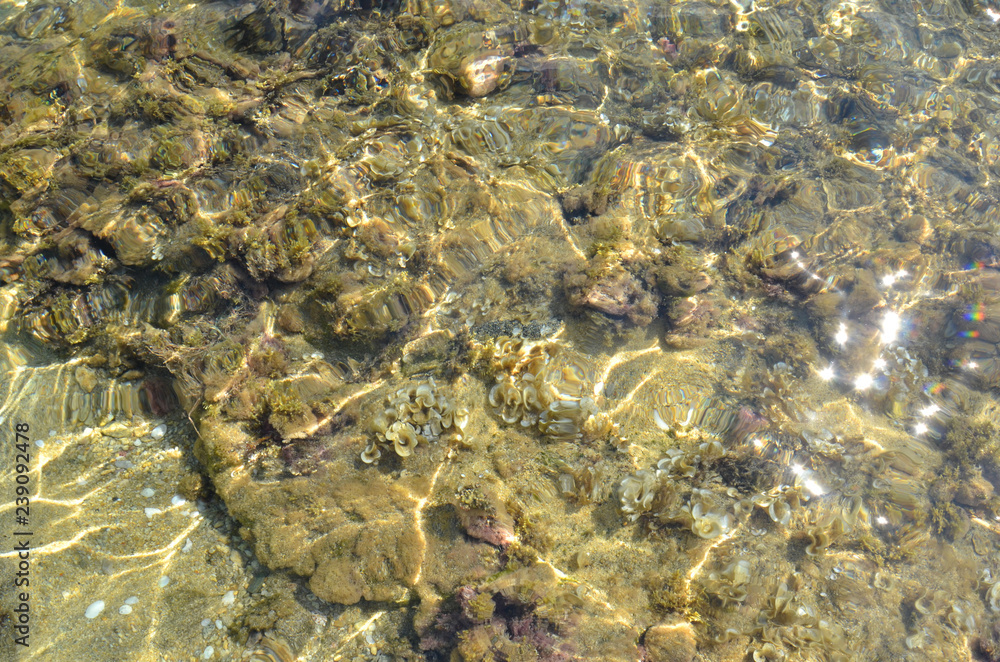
7;0;1000;662
